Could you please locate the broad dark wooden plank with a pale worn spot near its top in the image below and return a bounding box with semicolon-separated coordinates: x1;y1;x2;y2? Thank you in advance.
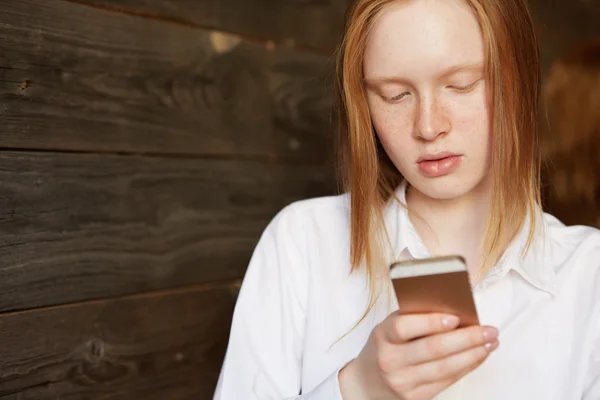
0;0;332;163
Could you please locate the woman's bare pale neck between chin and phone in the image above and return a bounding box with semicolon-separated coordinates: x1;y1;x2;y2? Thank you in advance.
406;180;491;281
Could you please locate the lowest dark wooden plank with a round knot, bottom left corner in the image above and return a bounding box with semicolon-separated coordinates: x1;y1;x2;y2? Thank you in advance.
0;285;239;400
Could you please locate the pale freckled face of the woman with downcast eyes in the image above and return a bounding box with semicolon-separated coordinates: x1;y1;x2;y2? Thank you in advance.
364;0;491;199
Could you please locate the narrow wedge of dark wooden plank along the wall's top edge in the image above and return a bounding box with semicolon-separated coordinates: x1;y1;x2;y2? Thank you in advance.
76;0;349;54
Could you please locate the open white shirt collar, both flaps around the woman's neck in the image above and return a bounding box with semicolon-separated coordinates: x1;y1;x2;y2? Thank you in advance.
384;181;556;295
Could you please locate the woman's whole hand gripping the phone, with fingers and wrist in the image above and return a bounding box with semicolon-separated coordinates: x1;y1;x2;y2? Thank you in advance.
338;312;498;400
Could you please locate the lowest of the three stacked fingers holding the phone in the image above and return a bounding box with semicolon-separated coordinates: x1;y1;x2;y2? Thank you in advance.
405;341;498;387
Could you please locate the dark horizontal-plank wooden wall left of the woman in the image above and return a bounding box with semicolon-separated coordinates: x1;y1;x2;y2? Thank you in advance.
0;0;345;400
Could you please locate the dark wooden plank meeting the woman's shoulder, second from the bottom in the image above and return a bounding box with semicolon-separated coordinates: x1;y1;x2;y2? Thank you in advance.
0;152;333;311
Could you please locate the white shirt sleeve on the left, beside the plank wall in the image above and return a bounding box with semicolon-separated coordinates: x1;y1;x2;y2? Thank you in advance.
213;205;342;400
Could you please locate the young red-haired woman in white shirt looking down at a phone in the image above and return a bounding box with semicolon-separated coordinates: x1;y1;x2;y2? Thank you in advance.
214;0;600;400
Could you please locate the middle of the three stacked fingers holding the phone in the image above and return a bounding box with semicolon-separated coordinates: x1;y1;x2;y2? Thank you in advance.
402;326;498;365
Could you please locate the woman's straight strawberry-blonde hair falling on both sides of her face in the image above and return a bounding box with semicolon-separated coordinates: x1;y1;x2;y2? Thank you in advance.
337;0;540;323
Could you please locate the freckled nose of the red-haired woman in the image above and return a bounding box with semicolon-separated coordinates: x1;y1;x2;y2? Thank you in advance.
413;95;451;141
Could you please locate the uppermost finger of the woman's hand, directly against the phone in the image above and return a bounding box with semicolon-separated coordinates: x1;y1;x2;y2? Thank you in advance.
382;312;460;344
